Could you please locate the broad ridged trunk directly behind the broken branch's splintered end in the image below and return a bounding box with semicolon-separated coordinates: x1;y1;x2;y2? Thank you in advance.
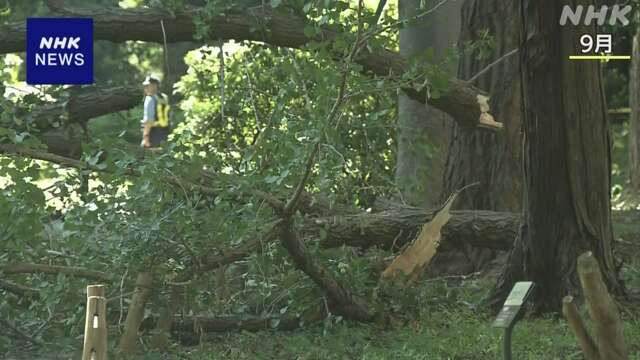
442;0;522;211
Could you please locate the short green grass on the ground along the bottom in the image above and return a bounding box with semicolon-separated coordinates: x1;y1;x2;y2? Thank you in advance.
132;296;640;360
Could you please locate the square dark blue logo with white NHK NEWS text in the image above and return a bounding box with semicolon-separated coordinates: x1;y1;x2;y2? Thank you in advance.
27;18;93;84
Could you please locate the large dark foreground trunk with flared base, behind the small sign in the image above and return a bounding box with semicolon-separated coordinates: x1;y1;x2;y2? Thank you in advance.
493;0;623;311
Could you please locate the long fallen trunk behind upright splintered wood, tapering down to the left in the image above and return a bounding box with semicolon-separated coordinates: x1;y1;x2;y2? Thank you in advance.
171;208;520;283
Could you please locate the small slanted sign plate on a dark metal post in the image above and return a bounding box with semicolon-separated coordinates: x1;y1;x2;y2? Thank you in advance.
492;281;534;360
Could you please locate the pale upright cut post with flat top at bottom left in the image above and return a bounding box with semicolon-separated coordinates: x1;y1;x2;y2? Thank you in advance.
82;285;107;360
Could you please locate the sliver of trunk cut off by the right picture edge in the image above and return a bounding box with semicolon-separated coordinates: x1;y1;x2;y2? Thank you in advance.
629;31;640;191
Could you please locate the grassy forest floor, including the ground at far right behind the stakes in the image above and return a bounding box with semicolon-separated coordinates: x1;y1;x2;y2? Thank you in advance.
16;210;640;360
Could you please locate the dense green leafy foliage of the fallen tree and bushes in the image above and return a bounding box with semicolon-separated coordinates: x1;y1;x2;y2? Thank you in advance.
0;0;640;358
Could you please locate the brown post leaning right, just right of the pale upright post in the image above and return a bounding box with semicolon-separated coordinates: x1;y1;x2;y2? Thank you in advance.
120;272;153;355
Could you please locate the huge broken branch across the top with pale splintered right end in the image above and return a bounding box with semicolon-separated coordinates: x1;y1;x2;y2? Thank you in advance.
0;3;502;130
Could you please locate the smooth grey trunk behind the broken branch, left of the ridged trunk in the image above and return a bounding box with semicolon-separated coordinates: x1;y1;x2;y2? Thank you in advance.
395;0;462;207
